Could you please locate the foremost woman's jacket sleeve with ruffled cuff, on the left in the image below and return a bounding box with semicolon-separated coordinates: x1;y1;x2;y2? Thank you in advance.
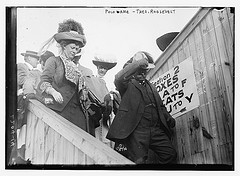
38;57;57;92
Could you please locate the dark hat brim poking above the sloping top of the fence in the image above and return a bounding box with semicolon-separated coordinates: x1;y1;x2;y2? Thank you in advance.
156;32;179;51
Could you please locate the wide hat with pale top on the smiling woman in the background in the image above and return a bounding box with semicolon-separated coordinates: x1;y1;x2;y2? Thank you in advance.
92;55;117;70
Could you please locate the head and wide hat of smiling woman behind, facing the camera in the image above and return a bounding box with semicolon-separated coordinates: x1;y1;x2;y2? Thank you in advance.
92;54;117;77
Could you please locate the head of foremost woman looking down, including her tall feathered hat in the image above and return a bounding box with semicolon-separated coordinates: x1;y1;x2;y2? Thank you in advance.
54;19;86;59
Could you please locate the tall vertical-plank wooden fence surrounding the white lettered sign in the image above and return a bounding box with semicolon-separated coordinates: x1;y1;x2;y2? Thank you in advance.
148;8;234;165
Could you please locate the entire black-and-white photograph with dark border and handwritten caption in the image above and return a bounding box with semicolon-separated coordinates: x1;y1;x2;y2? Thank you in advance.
3;0;236;175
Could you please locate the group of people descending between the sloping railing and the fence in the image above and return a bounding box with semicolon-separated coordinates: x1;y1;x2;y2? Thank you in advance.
9;19;177;164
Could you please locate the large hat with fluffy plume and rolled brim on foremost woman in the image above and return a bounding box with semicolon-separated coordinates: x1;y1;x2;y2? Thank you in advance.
53;19;86;47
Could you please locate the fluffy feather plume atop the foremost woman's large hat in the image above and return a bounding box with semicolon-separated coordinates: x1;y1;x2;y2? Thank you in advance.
58;19;84;35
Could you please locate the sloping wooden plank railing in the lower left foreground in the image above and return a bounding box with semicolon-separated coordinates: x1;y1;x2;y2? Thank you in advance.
25;100;134;165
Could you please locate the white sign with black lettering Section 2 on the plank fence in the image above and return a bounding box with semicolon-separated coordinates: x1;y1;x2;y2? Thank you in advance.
150;57;199;118
